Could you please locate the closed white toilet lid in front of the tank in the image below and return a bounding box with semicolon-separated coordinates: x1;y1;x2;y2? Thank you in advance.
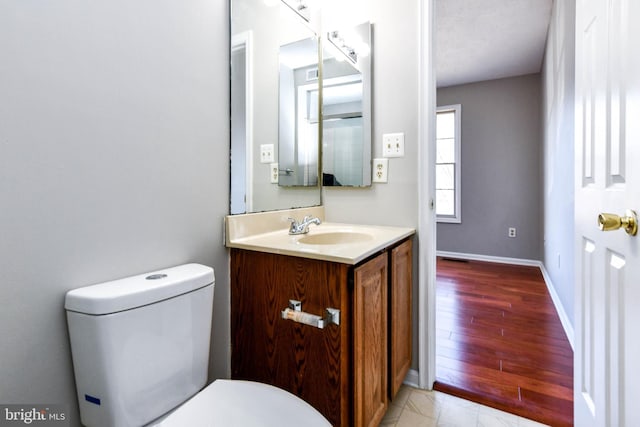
154;380;331;427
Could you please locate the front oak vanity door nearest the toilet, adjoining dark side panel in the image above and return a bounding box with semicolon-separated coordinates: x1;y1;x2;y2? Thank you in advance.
353;253;388;427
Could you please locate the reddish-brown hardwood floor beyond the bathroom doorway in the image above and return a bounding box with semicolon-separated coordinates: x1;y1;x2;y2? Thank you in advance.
435;258;573;426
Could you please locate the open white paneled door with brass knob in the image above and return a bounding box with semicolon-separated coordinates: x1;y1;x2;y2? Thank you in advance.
576;0;640;427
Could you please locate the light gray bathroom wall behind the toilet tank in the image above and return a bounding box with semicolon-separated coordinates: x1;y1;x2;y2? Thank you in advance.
0;0;229;426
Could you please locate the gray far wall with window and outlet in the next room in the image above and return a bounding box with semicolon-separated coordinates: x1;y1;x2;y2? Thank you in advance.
437;74;542;260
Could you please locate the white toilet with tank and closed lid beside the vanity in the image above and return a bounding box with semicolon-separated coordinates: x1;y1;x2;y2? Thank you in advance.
65;264;330;427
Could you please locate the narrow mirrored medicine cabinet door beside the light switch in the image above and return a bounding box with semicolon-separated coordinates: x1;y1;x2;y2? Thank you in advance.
322;22;372;187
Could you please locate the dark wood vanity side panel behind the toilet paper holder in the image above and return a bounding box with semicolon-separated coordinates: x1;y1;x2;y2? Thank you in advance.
230;249;350;427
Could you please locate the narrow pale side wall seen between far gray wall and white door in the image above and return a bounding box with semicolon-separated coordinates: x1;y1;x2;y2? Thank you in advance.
542;0;575;328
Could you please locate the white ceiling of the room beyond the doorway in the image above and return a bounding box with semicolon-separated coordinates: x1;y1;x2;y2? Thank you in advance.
435;0;553;87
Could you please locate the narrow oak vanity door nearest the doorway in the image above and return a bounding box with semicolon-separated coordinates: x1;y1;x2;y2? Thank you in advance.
389;240;413;399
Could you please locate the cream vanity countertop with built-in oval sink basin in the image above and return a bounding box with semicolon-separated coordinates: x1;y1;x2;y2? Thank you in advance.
226;222;415;264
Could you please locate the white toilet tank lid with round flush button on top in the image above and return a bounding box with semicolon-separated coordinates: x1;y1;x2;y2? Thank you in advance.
64;264;215;315
